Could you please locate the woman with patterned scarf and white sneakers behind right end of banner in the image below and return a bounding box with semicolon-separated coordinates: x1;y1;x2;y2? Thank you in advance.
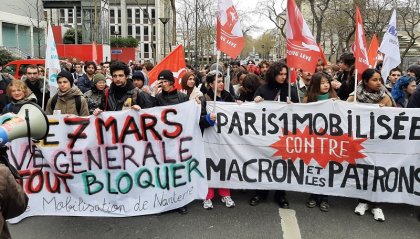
347;69;395;222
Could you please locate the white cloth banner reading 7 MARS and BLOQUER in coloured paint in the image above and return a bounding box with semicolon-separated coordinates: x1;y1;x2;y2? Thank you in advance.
9;101;207;222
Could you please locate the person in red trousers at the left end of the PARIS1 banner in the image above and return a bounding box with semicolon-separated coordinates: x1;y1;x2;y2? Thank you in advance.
200;70;235;209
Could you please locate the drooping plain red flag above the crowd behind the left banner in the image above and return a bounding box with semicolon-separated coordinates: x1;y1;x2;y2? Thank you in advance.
148;45;187;90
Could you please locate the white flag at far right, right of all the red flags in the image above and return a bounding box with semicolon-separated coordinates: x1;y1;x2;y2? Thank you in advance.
379;9;401;79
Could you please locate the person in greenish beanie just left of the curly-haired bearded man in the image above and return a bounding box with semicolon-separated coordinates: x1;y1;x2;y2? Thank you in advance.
83;73;107;114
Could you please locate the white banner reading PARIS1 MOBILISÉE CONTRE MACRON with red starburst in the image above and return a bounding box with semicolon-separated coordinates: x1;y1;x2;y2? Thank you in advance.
204;100;420;205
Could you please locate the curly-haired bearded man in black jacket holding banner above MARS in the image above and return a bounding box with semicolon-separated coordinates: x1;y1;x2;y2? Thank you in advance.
93;61;153;115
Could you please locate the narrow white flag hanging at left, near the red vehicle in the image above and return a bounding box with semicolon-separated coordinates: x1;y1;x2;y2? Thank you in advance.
44;24;61;97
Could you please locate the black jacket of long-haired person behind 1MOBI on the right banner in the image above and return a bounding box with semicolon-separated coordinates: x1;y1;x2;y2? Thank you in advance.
254;82;299;103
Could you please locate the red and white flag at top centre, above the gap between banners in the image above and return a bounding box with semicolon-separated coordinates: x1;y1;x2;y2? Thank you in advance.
216;0;245;59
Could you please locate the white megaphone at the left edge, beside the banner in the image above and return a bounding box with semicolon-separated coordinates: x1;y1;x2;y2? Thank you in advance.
0;103;49;146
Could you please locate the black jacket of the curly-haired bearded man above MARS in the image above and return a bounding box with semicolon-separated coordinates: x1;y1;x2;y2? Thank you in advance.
100;81;153;111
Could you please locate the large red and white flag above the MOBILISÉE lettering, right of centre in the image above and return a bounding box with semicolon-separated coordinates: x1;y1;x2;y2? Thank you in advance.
286;0;321;75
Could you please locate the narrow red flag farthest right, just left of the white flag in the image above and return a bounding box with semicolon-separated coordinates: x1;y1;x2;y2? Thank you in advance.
354;6;369;76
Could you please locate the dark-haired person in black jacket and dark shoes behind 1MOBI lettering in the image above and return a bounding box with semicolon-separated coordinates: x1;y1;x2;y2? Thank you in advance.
249;62;299;208
